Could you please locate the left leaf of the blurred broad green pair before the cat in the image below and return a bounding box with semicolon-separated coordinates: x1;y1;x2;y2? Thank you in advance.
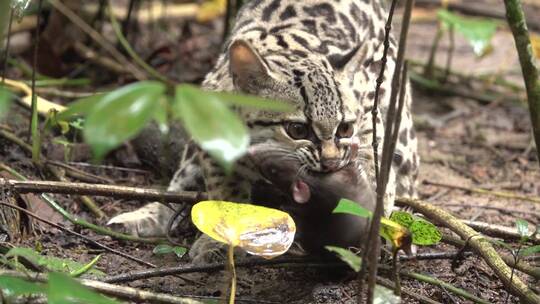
83;81;165;159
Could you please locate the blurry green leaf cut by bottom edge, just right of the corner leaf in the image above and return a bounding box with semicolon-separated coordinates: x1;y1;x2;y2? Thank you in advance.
47;272;119;304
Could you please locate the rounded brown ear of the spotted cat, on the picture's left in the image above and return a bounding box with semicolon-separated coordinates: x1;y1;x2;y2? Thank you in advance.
229;40;270;94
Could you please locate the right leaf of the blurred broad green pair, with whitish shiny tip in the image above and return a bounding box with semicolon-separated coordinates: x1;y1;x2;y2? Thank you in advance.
173;85;249;173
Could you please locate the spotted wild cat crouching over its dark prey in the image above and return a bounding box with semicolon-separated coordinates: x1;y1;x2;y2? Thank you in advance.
107;0;419;262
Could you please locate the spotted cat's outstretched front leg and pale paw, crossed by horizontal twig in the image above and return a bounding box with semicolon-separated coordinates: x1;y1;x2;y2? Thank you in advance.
107;153;203;237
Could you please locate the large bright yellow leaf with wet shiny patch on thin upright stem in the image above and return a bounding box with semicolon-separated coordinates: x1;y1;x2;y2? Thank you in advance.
191;201;296;259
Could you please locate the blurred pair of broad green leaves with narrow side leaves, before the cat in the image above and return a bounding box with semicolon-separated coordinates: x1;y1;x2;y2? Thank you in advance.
57;81;290;172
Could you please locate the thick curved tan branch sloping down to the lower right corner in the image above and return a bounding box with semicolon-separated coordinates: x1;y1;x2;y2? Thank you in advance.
397;198;540;304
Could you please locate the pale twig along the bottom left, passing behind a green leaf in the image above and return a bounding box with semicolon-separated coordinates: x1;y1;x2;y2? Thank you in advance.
0;270;204;304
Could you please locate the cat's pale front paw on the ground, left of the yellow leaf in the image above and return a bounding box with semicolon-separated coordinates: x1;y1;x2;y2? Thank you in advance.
107;202;174;237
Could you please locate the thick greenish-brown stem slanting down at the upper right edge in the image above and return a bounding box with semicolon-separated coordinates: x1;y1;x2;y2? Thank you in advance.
504;0;540;164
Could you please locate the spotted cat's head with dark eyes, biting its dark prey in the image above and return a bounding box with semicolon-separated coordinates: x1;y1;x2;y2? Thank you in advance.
228;40;369;172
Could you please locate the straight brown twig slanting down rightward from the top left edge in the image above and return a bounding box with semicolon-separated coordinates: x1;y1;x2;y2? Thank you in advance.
49;0;146;80
